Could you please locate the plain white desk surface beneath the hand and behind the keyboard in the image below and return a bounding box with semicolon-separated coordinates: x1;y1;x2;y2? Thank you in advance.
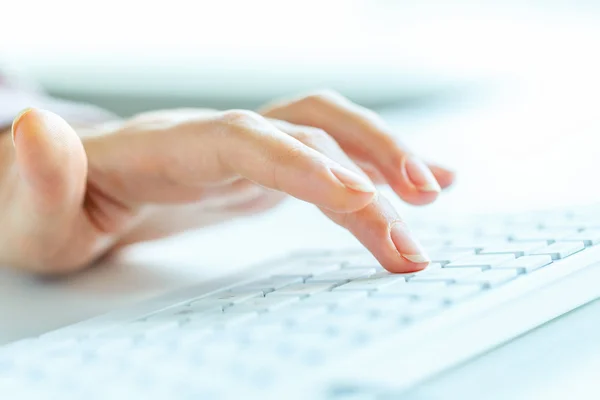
0;82;600;343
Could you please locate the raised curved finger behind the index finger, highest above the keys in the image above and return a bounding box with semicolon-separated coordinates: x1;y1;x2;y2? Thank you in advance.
261;92;448;204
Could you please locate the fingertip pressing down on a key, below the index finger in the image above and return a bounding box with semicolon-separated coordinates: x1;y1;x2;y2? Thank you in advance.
324;194;429;273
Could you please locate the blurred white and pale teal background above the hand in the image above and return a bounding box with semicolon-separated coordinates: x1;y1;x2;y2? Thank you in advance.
0;0;600;115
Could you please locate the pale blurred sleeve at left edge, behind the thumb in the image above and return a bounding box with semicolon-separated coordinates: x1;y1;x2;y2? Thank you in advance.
0;73;116;129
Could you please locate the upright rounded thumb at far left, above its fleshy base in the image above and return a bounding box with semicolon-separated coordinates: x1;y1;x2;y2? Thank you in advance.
12;108;87;216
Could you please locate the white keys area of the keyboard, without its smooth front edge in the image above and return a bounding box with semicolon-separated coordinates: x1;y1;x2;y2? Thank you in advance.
0;209;600;399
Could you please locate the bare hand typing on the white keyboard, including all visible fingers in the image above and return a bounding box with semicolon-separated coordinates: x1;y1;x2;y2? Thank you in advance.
0;92;453;273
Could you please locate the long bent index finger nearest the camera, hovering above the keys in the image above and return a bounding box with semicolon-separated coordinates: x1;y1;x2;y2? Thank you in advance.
86;111;376;211
